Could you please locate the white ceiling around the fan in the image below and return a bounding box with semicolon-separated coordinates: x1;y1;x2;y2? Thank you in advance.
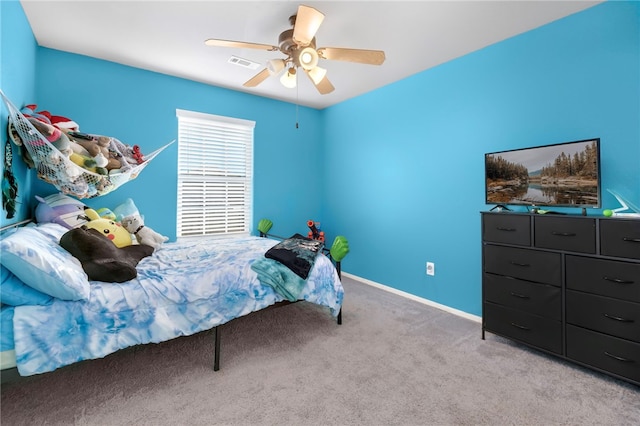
21;0;601;109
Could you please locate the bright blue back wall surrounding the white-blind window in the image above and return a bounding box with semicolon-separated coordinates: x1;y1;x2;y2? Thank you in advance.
31;48;322;239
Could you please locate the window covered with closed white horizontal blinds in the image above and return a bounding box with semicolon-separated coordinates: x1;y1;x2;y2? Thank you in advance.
176;109;255;237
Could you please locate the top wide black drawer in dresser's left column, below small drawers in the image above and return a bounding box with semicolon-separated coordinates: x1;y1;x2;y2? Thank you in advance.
483;245;562;286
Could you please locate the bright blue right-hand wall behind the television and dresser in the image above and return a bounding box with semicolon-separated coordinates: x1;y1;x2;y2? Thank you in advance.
322;2;640;314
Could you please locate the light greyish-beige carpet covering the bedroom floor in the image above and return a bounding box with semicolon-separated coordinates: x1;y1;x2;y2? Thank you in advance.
0;278;640;426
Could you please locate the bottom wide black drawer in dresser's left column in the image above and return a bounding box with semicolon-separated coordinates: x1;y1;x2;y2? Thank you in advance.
482;303;562;354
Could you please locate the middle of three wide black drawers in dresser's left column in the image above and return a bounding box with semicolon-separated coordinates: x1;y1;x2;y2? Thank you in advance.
484;274;562;321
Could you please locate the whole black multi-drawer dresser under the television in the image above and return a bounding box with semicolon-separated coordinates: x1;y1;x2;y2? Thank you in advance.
481;212;640;385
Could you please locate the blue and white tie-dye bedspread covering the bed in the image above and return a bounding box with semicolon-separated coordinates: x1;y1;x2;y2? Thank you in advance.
14;237;343;376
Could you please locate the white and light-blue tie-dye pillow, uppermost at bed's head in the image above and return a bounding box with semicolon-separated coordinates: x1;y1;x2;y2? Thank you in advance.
0;224;90;300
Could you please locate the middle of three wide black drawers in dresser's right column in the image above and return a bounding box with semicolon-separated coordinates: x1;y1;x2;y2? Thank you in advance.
567;290;640;343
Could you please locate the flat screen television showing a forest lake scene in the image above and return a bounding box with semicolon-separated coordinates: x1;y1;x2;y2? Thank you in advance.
485;138;601;208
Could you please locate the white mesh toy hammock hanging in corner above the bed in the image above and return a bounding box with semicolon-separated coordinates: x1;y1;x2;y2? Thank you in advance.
0;90;174;198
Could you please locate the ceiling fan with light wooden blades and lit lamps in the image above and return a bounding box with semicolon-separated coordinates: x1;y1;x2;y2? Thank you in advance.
205;5;385;95
